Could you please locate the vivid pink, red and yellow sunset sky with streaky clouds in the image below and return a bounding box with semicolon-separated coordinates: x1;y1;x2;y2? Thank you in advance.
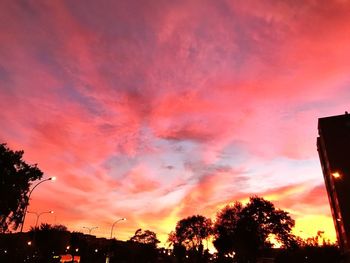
0;0;350;248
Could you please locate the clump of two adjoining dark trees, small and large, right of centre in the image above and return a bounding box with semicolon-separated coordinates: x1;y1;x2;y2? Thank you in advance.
169;196;300;262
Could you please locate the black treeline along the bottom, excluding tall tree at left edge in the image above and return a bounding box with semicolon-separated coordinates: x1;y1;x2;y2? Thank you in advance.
0;202;342;263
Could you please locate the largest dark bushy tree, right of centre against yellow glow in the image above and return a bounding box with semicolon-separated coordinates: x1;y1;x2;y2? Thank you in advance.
214;197;297;262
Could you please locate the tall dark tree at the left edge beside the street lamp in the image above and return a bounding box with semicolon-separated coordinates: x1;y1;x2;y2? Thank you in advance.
0;144;43;233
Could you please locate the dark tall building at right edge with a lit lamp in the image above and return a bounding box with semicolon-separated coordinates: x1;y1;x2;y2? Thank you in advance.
317;112;350;254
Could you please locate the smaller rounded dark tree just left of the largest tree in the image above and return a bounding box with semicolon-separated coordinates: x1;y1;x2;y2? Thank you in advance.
168;215;212;254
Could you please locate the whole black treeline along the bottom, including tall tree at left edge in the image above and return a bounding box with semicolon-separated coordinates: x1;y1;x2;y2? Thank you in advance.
0;144;340;263
